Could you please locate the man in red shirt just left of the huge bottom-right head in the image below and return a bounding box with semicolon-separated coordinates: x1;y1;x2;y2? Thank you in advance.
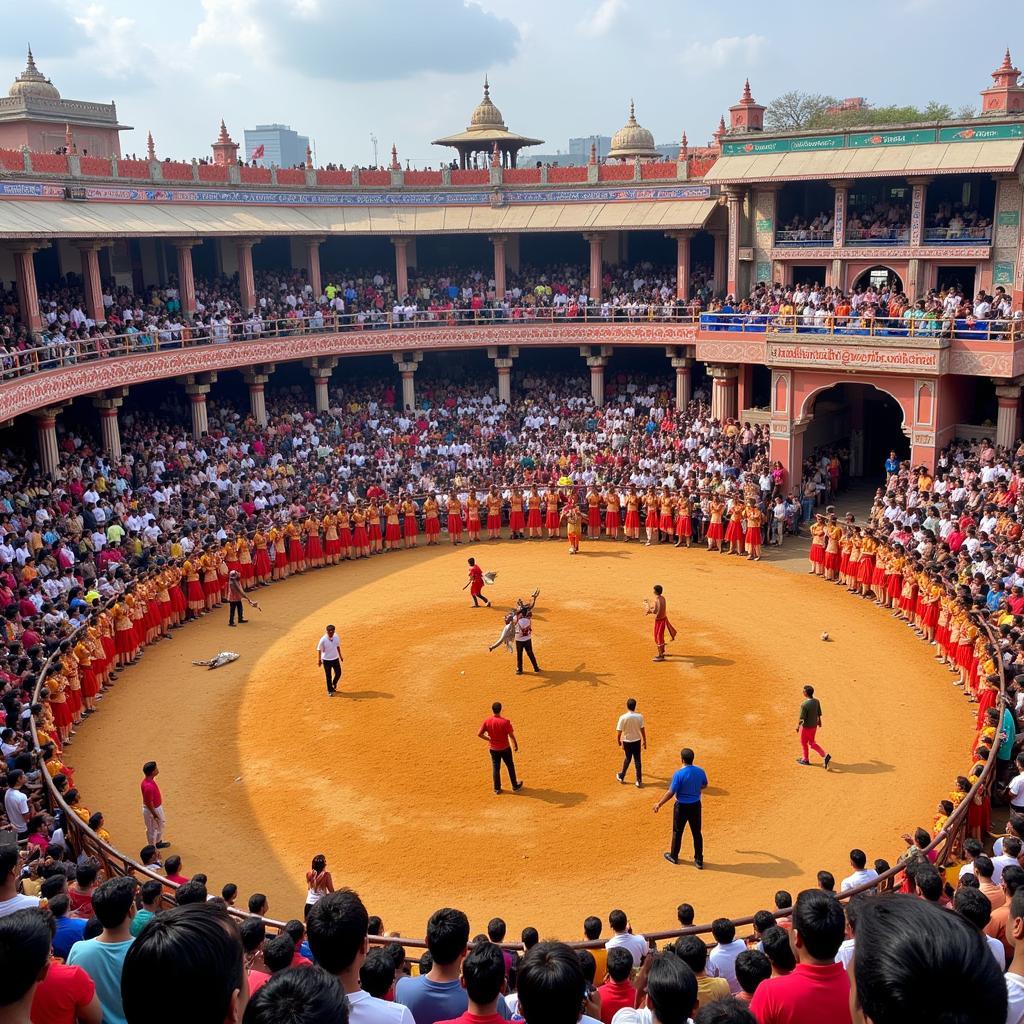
751;889;851;1024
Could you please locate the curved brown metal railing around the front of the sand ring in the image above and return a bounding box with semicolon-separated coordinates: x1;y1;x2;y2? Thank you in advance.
30;536;1006;950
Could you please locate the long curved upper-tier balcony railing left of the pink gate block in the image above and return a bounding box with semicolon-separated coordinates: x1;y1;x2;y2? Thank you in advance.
0;304;697;382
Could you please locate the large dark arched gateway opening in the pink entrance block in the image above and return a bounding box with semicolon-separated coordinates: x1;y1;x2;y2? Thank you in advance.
804;382;910;482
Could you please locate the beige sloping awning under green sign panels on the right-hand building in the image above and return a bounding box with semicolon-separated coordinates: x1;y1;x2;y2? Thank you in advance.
705;139;1024;184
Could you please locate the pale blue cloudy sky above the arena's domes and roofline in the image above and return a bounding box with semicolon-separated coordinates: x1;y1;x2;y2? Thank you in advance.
0;0;1007;167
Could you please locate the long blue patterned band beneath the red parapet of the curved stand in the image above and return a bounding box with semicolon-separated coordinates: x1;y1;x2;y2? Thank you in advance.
0;181;711;207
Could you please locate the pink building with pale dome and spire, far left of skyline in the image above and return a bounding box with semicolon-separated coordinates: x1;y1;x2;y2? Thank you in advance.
0;47;129;157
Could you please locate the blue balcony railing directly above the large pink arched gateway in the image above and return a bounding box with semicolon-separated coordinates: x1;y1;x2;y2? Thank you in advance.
700;312;1024;343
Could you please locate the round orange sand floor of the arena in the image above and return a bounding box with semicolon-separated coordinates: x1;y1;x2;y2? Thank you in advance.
69;541;972;938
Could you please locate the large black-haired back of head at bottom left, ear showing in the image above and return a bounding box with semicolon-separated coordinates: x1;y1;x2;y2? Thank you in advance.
119;902;249;1024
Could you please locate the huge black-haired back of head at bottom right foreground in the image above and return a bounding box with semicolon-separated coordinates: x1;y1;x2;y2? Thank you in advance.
850;894;1007;1024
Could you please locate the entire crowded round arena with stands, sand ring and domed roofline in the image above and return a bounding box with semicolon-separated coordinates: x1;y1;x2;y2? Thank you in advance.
0;18;1024;1024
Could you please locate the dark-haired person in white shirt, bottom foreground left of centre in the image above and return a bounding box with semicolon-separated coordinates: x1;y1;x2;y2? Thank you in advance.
306;889;413;1024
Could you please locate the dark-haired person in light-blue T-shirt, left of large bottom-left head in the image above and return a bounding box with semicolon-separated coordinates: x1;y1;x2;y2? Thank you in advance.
68;877;138;1024
